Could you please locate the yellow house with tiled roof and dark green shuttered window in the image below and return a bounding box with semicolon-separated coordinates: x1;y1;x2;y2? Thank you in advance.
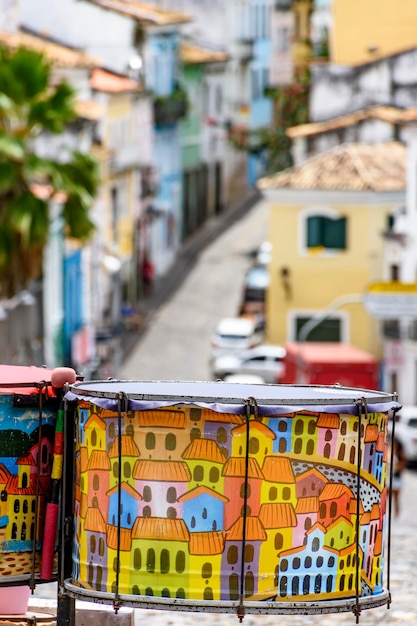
258;142;406;357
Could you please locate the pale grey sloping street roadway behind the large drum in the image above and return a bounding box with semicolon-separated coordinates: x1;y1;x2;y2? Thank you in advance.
120;200;267;380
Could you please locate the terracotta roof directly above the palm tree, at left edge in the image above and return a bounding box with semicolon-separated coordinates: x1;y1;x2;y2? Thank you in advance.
0;30;100;68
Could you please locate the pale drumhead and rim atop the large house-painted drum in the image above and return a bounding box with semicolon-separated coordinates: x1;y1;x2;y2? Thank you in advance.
68;380;400;410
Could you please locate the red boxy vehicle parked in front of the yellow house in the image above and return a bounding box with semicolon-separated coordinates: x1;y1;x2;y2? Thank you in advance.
280;342;379;390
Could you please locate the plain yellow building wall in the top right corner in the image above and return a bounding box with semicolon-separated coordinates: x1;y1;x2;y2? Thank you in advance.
330;0;417;65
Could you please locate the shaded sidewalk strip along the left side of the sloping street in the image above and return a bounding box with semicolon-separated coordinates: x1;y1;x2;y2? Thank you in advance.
122;189;261;359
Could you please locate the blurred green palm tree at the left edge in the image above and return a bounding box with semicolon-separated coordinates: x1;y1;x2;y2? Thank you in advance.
0;47;99;299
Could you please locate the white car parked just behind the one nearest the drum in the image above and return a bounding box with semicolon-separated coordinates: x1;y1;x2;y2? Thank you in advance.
211;317;263;362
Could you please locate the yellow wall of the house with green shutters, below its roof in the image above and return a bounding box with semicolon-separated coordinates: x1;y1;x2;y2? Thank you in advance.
265;189;404;356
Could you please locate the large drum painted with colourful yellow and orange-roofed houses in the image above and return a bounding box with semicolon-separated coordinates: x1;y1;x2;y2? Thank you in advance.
64;381;400;619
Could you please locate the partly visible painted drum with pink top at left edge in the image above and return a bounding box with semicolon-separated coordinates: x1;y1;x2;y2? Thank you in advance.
0;365;69;613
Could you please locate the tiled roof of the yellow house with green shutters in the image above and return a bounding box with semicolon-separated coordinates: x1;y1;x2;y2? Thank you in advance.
258;141;407;192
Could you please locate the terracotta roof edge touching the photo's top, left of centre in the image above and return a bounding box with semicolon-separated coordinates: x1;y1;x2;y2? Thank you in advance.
89;0;192;26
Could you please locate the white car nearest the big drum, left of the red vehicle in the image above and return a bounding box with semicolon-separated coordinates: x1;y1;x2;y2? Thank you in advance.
212;345;286;383
